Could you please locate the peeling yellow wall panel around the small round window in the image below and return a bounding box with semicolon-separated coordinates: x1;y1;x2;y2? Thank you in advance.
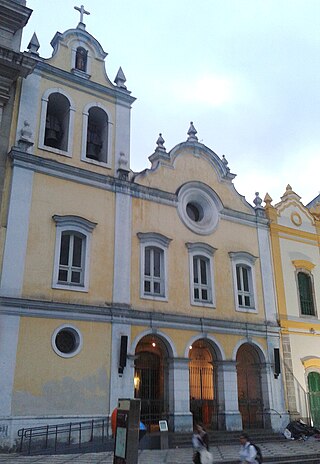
13;317;111;415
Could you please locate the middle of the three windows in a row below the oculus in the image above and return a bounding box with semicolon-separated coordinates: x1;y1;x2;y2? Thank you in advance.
193;256;212;303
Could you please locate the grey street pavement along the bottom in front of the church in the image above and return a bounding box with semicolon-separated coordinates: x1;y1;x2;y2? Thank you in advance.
0;439;320;464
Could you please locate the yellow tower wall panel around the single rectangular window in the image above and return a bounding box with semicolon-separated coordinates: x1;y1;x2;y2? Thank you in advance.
23;174;115;304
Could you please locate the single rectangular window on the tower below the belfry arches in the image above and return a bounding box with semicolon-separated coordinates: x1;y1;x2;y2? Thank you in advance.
58;232;85;285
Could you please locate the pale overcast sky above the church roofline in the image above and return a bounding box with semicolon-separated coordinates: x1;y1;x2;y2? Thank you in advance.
22;0;320;204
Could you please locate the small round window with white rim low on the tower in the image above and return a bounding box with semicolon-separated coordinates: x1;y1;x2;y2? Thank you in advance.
52;326;82;358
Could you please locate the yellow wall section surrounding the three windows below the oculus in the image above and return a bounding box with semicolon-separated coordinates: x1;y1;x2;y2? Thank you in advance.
131;192;264;321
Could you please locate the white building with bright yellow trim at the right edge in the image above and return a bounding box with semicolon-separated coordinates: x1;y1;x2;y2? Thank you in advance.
265;185;320;427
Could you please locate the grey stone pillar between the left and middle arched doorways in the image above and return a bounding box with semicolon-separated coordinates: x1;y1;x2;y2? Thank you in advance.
168;358;193;432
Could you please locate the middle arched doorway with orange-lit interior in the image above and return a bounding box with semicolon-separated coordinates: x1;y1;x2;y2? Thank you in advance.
189;340;218;429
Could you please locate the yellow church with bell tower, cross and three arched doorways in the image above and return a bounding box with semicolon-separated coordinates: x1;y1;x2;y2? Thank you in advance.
0;8;287;452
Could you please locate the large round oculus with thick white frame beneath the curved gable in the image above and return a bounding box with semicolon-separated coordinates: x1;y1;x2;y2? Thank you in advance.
178;184;219;235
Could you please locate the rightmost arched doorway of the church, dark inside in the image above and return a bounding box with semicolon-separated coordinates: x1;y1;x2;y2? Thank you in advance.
237;343;263;429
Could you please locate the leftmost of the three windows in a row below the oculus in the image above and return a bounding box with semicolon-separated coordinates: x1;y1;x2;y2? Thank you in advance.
144;247;164;296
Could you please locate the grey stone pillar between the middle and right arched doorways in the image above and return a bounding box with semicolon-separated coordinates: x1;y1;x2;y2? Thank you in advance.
215;361;242;430
